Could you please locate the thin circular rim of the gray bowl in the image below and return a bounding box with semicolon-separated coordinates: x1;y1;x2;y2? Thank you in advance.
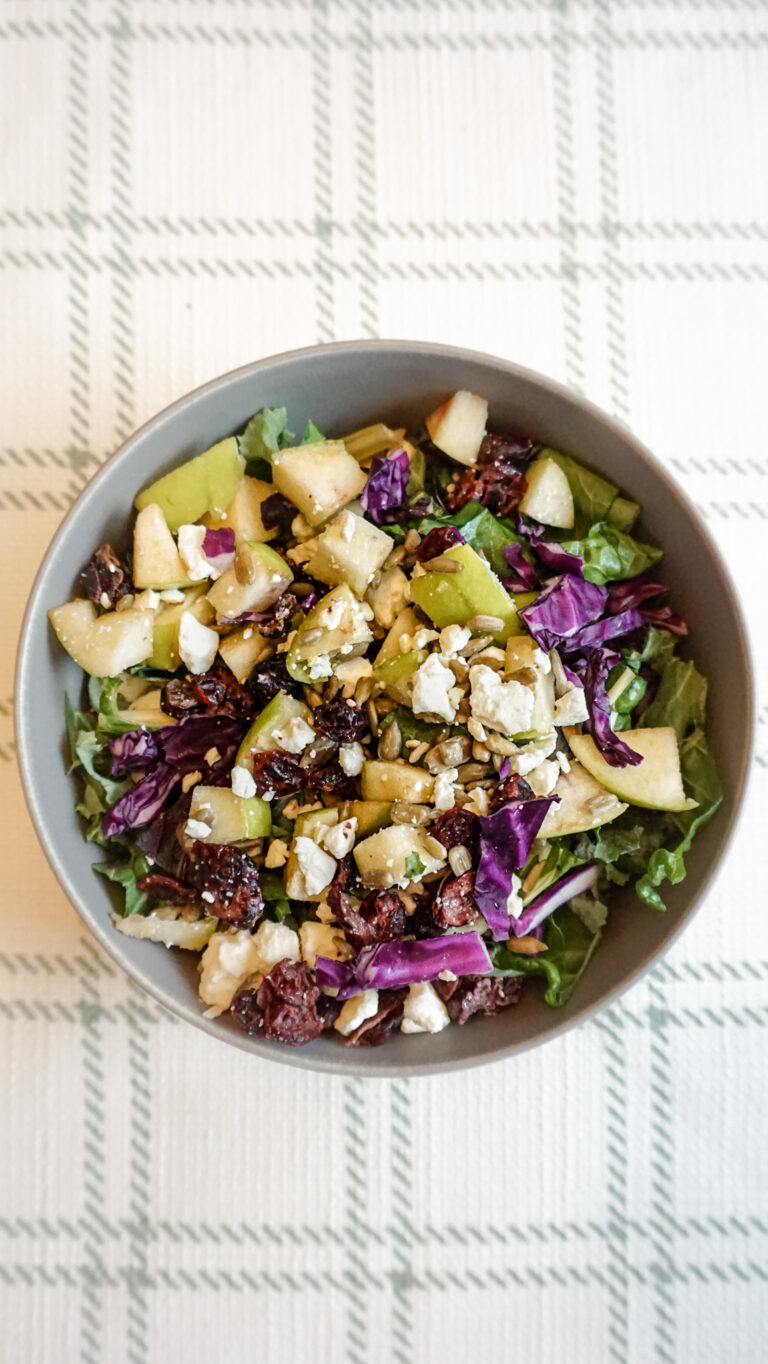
14;338;756;1079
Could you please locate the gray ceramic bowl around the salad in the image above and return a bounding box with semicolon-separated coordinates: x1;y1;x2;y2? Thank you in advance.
16;341;753;1075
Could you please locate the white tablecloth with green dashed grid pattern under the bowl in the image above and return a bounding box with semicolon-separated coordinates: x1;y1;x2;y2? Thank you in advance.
0;0;768;1364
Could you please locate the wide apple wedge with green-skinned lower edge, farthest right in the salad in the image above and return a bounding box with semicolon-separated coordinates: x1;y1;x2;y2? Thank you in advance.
567;726;697;822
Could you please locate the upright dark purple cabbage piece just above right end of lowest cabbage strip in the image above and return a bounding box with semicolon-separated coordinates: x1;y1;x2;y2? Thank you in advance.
473;795;558;943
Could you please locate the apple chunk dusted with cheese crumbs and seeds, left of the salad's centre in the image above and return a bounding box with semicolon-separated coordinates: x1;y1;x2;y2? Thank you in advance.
285;584;374;685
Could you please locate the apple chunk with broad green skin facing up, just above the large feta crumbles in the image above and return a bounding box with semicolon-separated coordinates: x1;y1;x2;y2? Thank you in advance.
411;544;524;644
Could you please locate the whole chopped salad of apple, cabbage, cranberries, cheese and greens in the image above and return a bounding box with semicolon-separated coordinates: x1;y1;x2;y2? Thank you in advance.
49;391;720;1046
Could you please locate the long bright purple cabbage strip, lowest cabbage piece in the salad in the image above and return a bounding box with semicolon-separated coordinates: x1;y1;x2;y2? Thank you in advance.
315;930;491;998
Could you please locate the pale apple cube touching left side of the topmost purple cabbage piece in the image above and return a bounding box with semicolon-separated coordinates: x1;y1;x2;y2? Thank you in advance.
271;441;367;525
